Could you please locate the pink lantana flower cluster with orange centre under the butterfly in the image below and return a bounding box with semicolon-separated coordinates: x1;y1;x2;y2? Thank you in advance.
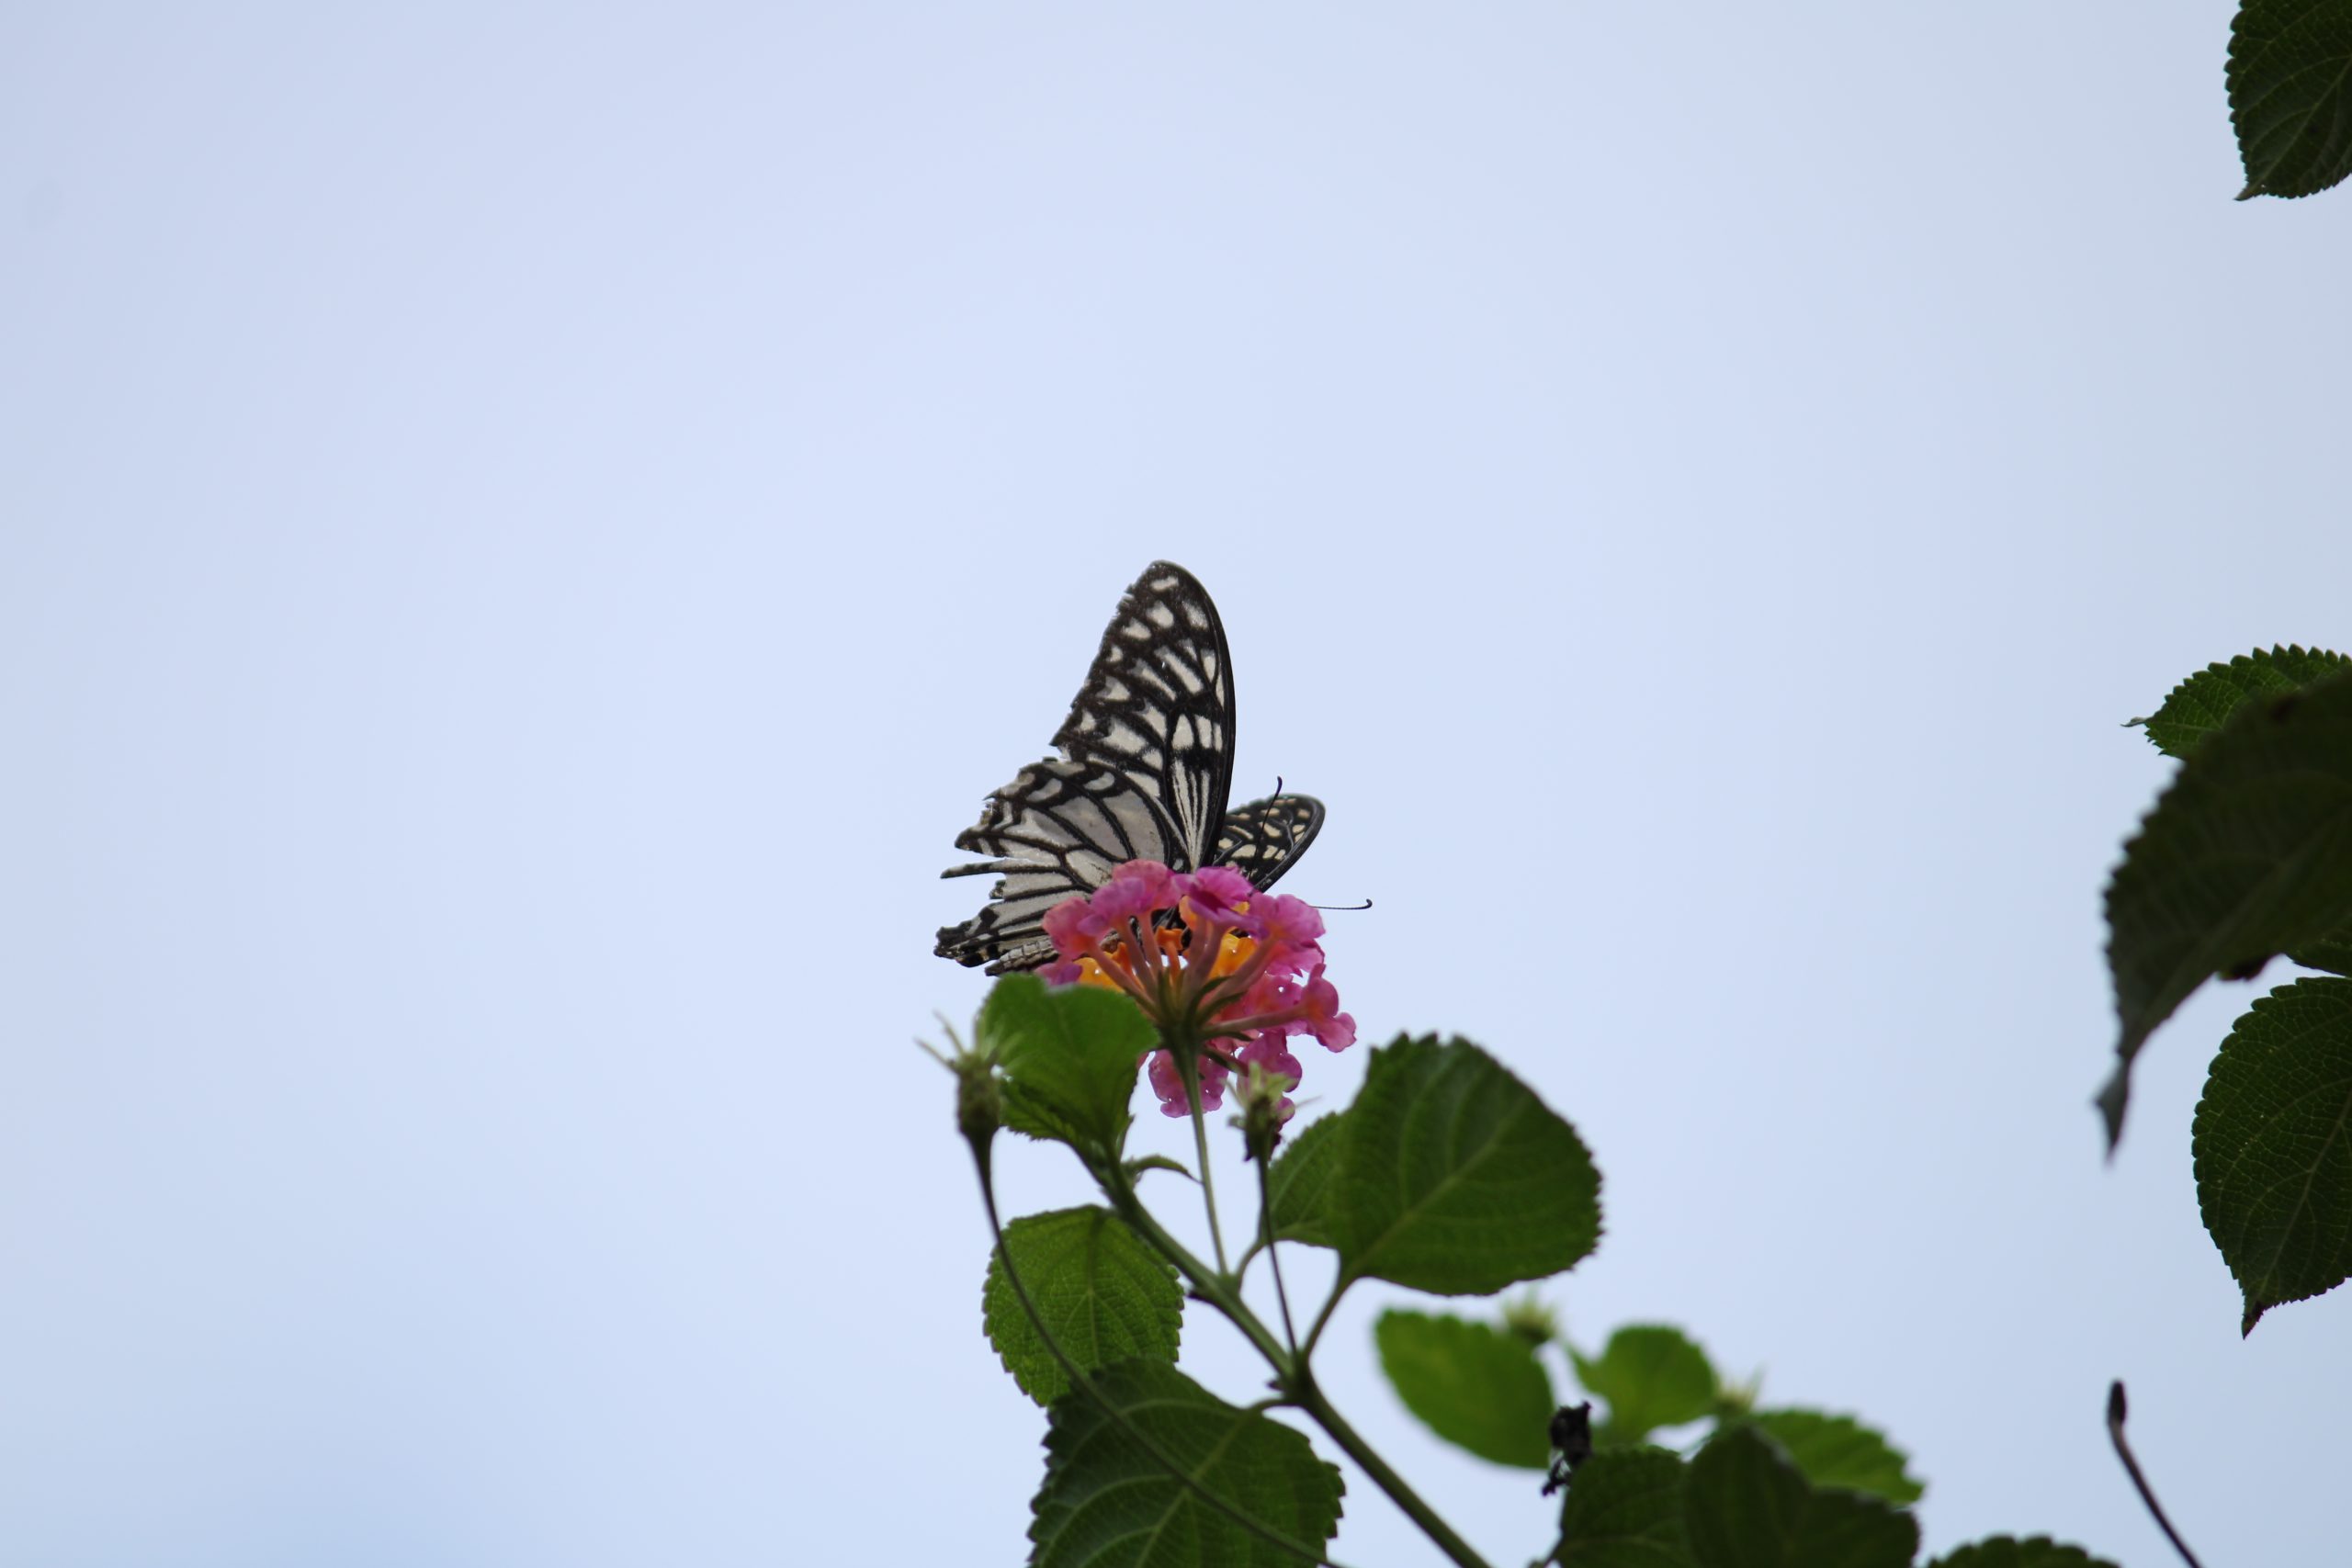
1045;861;1355;1119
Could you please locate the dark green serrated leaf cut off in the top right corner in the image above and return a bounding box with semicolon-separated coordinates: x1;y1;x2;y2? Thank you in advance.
2230;0;2352;202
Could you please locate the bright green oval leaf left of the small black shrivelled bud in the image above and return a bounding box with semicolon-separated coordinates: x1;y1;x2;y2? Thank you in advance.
1371;1312;1559;1470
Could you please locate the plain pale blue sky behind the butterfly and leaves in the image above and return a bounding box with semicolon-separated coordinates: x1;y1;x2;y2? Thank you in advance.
0;3;2352;1568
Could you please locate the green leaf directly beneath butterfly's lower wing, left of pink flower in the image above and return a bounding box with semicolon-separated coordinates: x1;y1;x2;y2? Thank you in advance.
976;976;1155;1159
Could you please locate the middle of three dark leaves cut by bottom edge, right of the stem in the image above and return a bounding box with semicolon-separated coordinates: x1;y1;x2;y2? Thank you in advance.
1684;1425;1919;1568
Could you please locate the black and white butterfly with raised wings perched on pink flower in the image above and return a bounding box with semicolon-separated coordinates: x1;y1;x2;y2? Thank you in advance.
938;562;1322;976
